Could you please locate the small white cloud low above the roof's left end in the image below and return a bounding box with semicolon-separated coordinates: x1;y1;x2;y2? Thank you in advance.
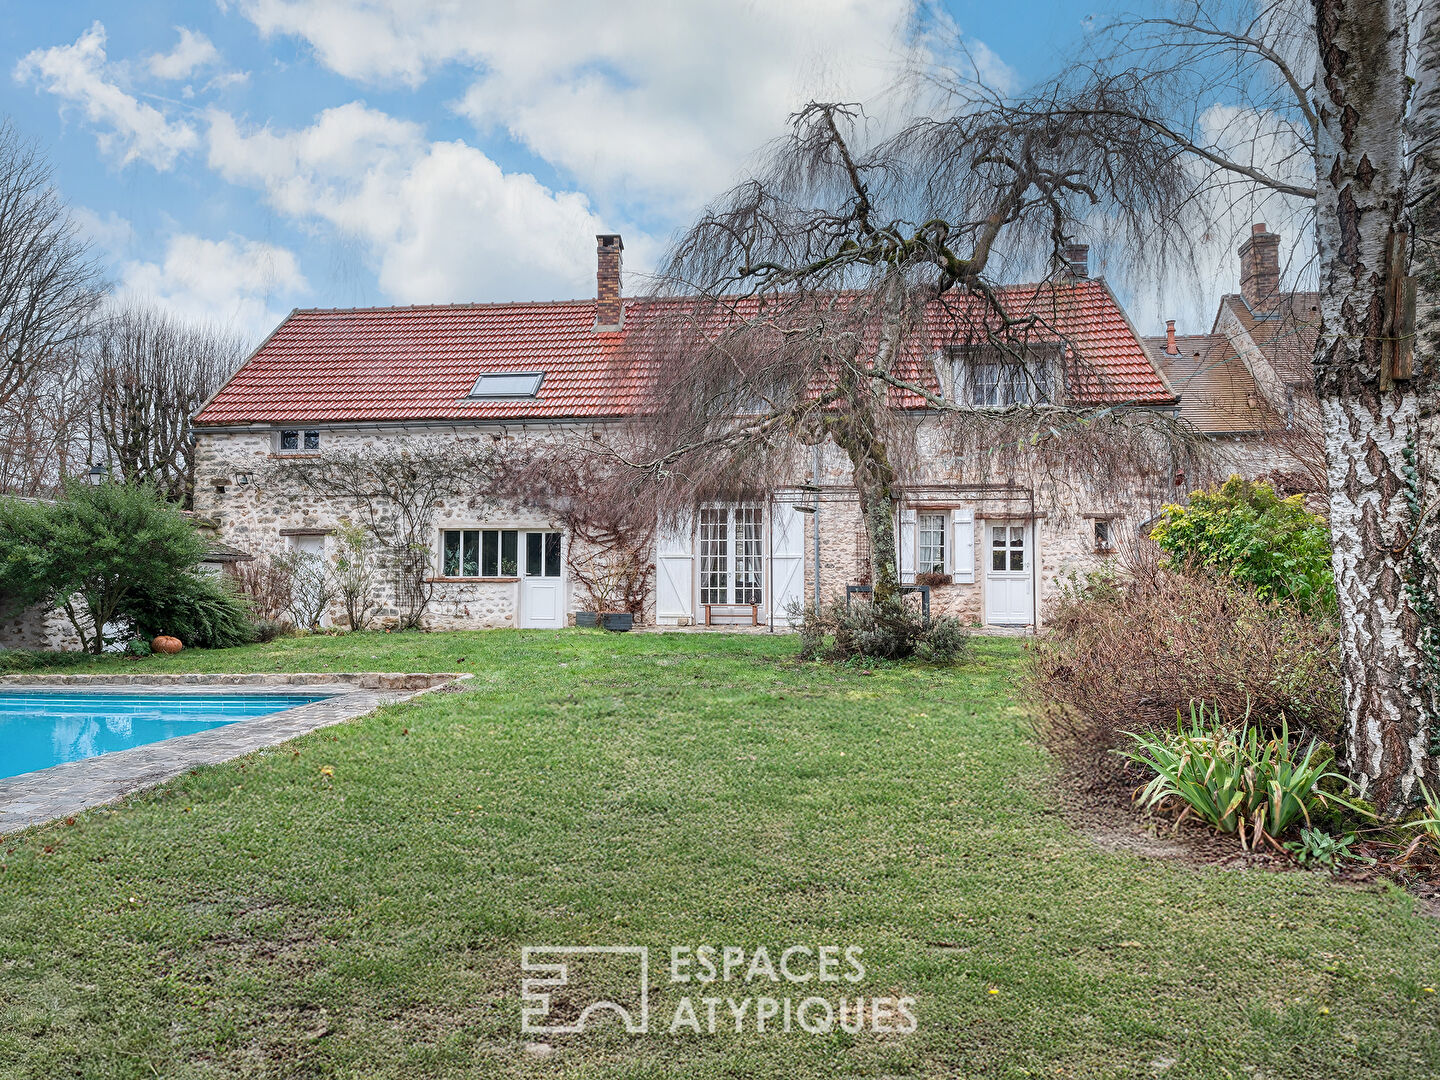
117;233;310;340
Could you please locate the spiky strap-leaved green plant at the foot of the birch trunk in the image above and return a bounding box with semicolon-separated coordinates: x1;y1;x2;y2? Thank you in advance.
1117;703;1359;850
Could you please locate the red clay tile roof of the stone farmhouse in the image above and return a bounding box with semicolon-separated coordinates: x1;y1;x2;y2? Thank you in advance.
196;279;1175;426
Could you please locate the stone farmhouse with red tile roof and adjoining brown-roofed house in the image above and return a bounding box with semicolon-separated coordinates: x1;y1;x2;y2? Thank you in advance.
174;226;1313;639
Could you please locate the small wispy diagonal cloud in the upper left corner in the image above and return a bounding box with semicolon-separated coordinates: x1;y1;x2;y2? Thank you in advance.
14;22;199;170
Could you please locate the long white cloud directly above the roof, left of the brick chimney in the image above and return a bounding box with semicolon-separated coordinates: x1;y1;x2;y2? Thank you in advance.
209;102;654;302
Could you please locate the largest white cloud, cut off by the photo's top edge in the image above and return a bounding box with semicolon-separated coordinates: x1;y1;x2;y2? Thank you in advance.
233;0;1014;216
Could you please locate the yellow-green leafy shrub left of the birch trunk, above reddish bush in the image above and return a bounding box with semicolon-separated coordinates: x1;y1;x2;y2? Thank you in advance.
1151;477;1335;611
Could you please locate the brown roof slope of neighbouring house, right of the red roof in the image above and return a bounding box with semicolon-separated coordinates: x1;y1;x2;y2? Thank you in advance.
1145;334;1283;435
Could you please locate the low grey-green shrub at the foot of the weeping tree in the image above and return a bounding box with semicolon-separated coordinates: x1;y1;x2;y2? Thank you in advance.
791;600;969;664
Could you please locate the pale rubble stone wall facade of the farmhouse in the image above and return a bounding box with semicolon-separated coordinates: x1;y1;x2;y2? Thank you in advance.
171;425;1307;642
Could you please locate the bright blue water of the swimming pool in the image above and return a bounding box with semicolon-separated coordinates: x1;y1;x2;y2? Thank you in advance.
0;690;325;776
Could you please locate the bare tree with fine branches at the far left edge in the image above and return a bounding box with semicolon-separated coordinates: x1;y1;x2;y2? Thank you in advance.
0;120;102;406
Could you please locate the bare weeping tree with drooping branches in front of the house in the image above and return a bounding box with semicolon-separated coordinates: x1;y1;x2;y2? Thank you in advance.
625;98;1200;602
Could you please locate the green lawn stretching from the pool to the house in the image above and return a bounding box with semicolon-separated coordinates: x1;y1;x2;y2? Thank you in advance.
0;631;1440;1080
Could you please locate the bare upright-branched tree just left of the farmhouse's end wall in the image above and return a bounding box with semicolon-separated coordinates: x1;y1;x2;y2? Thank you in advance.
89;304;248;505
